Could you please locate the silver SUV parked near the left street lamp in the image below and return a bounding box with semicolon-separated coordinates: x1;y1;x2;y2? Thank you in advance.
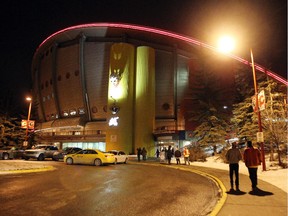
23;144;58;161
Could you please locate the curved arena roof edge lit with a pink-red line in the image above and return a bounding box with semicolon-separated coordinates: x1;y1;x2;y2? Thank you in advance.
36;23;288;86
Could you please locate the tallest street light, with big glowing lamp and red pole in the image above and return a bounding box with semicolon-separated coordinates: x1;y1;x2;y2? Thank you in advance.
218;36;266;171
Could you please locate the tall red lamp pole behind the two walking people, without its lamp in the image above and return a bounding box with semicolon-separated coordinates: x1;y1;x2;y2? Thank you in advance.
250;49;266;171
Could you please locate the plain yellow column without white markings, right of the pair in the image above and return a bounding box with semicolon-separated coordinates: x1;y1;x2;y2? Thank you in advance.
134;46;155;156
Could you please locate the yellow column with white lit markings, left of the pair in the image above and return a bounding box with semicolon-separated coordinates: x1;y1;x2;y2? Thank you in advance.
106;43;135;154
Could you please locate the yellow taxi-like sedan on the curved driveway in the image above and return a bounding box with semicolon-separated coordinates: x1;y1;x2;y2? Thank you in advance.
64;149;115;166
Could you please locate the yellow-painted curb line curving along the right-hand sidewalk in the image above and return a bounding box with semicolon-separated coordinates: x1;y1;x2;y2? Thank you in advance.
135;162;227;216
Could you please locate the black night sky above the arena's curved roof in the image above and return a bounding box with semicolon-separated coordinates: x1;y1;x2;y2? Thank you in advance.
0;0;287;110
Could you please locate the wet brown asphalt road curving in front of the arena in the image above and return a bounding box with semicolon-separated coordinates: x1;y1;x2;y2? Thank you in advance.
0;161;218;216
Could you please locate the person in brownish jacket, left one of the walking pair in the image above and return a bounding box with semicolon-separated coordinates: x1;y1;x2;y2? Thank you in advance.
225;142;242;191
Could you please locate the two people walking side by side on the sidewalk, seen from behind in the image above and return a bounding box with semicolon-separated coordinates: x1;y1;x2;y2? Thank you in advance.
225;141;262;191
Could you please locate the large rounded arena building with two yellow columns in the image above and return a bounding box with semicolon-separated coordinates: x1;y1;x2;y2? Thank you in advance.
32;23;286;156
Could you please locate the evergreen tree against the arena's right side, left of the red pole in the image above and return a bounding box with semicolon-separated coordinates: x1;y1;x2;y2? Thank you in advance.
187;54;230;153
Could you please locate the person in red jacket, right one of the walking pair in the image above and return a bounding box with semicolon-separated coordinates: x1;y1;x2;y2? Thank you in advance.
243;141;262;191
